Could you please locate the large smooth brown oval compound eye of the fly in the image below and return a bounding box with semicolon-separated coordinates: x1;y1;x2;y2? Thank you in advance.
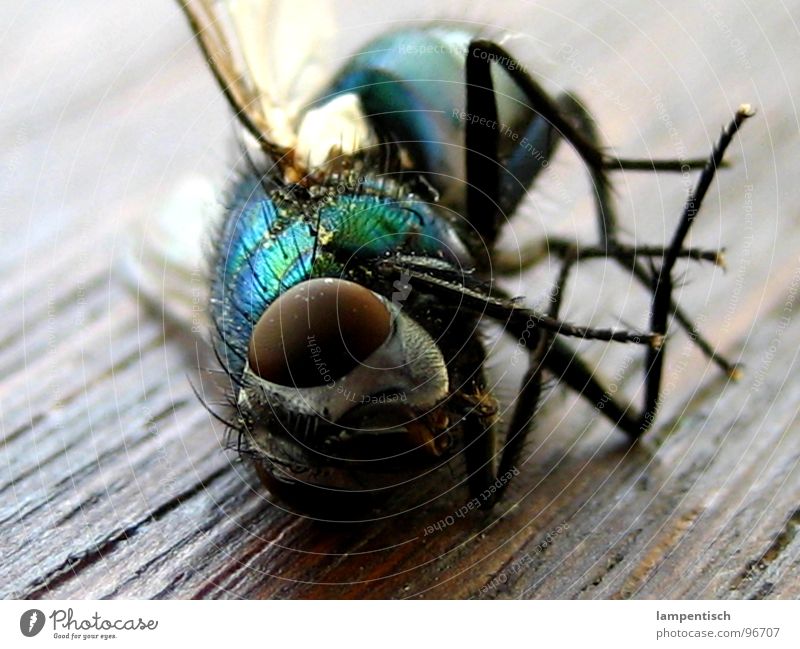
248;278;392;388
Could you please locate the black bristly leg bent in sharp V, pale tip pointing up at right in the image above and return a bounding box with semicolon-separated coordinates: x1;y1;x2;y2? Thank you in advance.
545;106;753;439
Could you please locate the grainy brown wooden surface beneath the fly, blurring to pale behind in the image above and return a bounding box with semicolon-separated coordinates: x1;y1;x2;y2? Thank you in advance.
0;0;800;598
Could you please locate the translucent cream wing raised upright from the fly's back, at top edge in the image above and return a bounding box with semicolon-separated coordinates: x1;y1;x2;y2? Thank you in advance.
180;0;366;181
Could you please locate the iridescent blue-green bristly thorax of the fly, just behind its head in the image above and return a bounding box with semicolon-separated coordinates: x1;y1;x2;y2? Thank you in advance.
212;172;466;372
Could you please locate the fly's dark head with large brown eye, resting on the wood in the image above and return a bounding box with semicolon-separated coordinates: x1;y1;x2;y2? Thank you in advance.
212;177;482;505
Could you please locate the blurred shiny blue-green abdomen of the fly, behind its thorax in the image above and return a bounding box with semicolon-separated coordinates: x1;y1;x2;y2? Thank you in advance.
317;27;552;212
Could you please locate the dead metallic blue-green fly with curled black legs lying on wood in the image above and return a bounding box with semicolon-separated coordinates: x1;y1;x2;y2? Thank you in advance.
167;0;753;509
